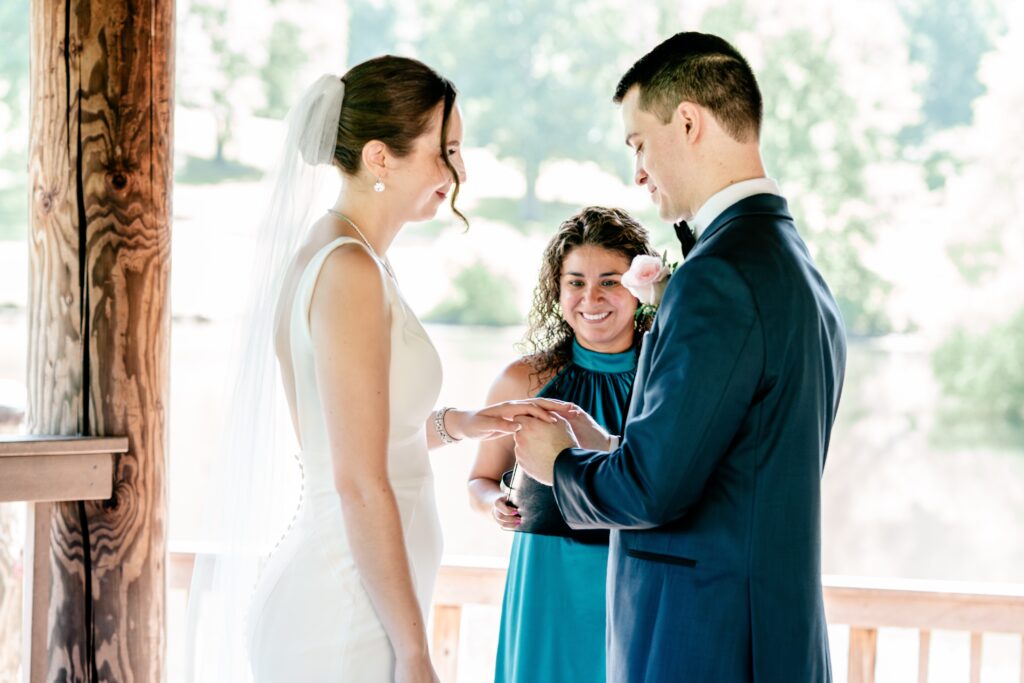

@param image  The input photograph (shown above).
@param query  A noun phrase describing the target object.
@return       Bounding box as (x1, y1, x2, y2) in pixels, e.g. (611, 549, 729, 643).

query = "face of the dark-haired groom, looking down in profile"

(623, 86, 692, 223)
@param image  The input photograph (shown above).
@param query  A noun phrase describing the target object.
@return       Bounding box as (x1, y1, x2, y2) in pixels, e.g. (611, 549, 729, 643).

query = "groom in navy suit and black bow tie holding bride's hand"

(516, 33, 846, 683)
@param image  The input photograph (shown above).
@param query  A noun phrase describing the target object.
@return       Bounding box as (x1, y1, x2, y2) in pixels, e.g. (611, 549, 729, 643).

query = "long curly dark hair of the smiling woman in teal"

(519, 206, 657, 377)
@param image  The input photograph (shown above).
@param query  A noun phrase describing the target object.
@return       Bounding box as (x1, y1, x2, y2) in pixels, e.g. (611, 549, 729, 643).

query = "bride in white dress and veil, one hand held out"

(189, 56, 551, 683)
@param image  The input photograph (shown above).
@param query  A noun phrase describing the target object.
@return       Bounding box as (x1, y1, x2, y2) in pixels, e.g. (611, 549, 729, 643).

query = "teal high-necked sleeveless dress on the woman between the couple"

(495, 341, 637, 683)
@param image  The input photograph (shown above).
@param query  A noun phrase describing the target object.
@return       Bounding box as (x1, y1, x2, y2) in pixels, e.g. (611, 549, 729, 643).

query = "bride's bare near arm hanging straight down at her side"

(310, 248, 430, 680)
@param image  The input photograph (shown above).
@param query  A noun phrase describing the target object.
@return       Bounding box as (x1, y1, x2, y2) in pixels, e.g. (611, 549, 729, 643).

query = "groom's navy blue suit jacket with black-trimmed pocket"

(554, 195, 846, 683)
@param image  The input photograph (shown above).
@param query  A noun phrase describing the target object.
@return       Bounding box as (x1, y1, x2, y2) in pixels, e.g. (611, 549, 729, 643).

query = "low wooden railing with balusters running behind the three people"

(170, 552, 1024, 683)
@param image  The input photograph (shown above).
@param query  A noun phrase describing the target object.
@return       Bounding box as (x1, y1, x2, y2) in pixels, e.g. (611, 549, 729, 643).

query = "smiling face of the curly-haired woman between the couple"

(558, 245, 637, 353)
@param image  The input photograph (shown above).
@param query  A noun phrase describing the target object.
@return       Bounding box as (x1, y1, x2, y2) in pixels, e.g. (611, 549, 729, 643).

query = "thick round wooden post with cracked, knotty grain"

(24, 0, 174, 681)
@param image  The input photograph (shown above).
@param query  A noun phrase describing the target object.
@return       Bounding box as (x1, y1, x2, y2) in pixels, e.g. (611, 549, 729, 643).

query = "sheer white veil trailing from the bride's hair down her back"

(185, 75, 345, 683)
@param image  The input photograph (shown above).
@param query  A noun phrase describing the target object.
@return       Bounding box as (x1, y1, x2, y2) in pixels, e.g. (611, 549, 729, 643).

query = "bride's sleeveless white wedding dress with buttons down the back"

(248, 238, 441, 683)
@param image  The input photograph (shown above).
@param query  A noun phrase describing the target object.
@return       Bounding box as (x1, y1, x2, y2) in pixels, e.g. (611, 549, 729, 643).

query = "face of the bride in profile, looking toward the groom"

(384, 102, 466, 221)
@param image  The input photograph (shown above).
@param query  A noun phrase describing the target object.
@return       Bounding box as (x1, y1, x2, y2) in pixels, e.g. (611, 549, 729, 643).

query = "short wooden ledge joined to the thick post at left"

(0, 436, 128, 503)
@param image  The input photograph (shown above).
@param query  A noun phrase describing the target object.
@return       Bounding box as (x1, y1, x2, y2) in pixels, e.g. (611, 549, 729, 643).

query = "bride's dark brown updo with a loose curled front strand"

(334, 54, 467, 222)
